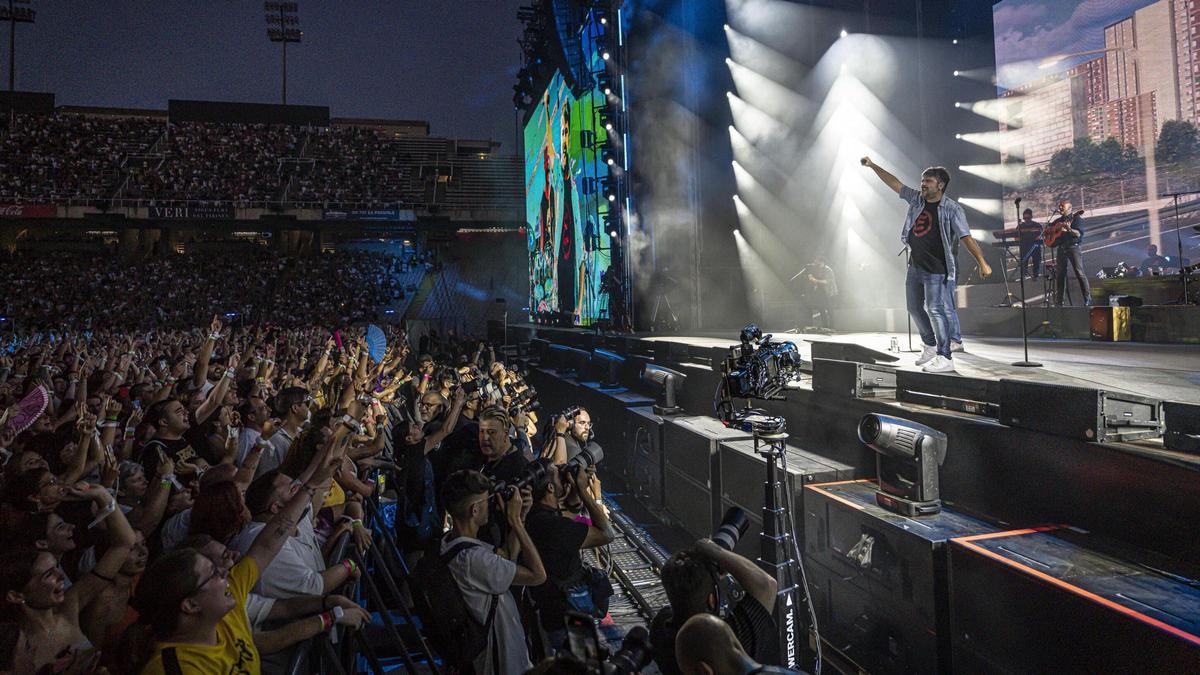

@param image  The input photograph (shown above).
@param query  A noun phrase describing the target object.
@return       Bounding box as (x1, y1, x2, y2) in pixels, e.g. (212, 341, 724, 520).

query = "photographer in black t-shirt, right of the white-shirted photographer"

(526, 459, 613, 656)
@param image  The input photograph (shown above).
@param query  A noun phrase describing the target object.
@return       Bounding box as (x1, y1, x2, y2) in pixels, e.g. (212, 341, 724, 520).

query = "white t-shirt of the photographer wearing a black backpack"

(442, 537, 533, 675)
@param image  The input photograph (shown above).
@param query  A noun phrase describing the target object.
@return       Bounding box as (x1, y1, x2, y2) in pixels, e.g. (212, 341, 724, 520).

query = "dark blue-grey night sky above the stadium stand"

(9, 0, 522, 153)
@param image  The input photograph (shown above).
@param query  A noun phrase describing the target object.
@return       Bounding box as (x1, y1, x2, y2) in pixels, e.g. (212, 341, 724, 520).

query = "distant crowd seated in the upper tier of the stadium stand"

(0, 112, 511, 209)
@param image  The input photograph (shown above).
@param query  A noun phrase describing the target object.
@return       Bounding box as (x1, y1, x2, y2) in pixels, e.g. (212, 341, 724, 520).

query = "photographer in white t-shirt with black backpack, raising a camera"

(440, 471, 546, 675)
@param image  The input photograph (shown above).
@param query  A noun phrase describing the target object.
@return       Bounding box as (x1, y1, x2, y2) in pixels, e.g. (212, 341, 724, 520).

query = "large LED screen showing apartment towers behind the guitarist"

(993, 0, 1200, 270)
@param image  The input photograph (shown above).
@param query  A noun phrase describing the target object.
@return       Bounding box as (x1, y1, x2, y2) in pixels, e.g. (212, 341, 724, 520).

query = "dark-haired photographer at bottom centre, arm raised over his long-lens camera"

(650, 539, 780, 675)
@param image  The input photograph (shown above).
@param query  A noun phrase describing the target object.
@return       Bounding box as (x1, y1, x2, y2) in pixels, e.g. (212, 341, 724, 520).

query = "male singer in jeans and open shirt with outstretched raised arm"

(862, 157, 991, 372)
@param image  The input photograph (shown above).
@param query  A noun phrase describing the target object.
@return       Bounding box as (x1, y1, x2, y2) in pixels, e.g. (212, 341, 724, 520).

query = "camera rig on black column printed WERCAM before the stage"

(713, 323, 821, 675)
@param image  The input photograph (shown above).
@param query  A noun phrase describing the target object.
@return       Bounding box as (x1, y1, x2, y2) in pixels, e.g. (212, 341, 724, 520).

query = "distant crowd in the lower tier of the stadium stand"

(0, 246, 417, 330)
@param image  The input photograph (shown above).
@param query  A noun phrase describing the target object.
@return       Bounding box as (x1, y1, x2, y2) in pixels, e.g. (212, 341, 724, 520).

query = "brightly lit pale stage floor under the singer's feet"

(640, 329, 1200, 402)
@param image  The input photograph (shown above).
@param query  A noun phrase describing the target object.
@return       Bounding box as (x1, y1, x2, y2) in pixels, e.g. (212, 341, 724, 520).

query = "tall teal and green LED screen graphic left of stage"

(524, 63, 617, 325)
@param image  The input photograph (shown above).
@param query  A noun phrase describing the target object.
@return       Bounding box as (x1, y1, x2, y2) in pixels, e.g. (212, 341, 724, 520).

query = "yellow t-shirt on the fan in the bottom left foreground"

(142, 557, 262, 675)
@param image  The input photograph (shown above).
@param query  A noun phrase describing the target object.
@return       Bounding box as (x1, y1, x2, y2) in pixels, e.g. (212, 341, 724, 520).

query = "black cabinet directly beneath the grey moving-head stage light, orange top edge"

(804, 480, 995, 675)
